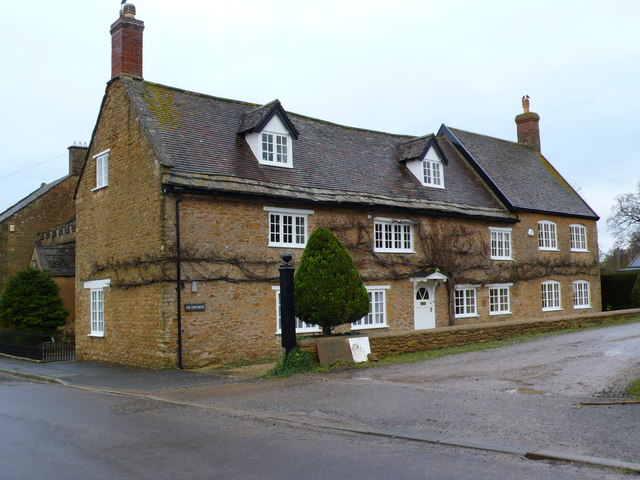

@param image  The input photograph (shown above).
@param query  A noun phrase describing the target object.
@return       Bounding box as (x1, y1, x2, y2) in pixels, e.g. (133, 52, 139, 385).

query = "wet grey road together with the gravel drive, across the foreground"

(0, 325, 640, 480)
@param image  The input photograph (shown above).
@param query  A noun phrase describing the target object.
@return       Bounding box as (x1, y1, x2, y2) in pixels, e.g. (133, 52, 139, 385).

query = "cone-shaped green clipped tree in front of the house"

(294, 228, 369, 335)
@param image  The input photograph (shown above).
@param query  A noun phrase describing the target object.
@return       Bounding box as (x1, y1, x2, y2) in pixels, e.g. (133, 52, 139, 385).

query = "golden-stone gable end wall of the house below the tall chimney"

(76, 79, 175, 368)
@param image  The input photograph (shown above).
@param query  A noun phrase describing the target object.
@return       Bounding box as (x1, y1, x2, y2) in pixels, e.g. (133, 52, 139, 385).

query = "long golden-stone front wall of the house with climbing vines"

(165, 195, 600, 366)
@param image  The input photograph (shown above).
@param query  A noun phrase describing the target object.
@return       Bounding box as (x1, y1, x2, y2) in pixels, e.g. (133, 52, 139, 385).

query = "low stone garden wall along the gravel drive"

(298, 309, 640, 356)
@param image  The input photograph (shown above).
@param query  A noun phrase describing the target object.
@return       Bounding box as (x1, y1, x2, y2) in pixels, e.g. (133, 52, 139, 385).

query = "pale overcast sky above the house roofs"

(0, 0, 640, 252)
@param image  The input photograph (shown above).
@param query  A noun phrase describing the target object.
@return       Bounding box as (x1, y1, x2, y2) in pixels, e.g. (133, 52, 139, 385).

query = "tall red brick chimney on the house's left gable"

(111, 1, 144, 78)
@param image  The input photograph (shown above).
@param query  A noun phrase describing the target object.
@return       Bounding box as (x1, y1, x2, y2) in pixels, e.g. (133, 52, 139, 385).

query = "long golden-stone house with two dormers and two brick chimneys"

(76, 4, 601, 368)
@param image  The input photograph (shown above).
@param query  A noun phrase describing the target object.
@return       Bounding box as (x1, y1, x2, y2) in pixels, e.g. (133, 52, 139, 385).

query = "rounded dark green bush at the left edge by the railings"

(0, 268, 68, 333)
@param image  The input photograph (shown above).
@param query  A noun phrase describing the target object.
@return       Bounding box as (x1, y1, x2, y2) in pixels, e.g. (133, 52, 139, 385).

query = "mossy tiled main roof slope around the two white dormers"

(122, 78, 507, 216)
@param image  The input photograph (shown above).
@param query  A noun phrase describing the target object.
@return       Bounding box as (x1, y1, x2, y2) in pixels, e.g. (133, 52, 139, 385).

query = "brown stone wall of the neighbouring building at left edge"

(0, 176, 78, 292)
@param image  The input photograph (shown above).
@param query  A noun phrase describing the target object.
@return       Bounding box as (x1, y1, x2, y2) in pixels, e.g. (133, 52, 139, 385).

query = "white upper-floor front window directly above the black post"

(264, 207, 313, 248)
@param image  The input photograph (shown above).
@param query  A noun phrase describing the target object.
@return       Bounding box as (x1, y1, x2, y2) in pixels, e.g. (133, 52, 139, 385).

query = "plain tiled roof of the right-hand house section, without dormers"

(441, 126, 598, 218)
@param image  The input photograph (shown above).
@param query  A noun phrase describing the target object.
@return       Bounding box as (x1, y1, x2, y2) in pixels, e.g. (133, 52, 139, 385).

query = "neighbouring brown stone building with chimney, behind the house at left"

(0, 145, 87, 292)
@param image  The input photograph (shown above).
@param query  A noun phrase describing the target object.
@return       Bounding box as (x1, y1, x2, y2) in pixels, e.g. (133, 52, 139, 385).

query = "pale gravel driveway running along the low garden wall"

(155, 324, 640, 462)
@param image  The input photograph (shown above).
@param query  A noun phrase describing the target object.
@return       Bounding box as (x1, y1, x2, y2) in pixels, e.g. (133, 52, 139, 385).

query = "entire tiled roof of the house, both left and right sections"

(119, 76, 595, 220)
